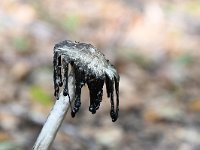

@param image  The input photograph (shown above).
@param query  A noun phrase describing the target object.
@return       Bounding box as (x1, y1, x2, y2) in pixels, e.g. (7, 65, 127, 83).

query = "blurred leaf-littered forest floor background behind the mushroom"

(0, 0, 200, 150)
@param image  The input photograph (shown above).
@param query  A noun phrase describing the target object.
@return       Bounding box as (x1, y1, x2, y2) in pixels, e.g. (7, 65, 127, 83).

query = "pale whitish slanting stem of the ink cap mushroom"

(33, 70, 74, 150)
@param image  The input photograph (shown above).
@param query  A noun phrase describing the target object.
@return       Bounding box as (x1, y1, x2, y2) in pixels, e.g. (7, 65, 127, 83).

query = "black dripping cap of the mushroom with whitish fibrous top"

(53, 40, 120, 122)
